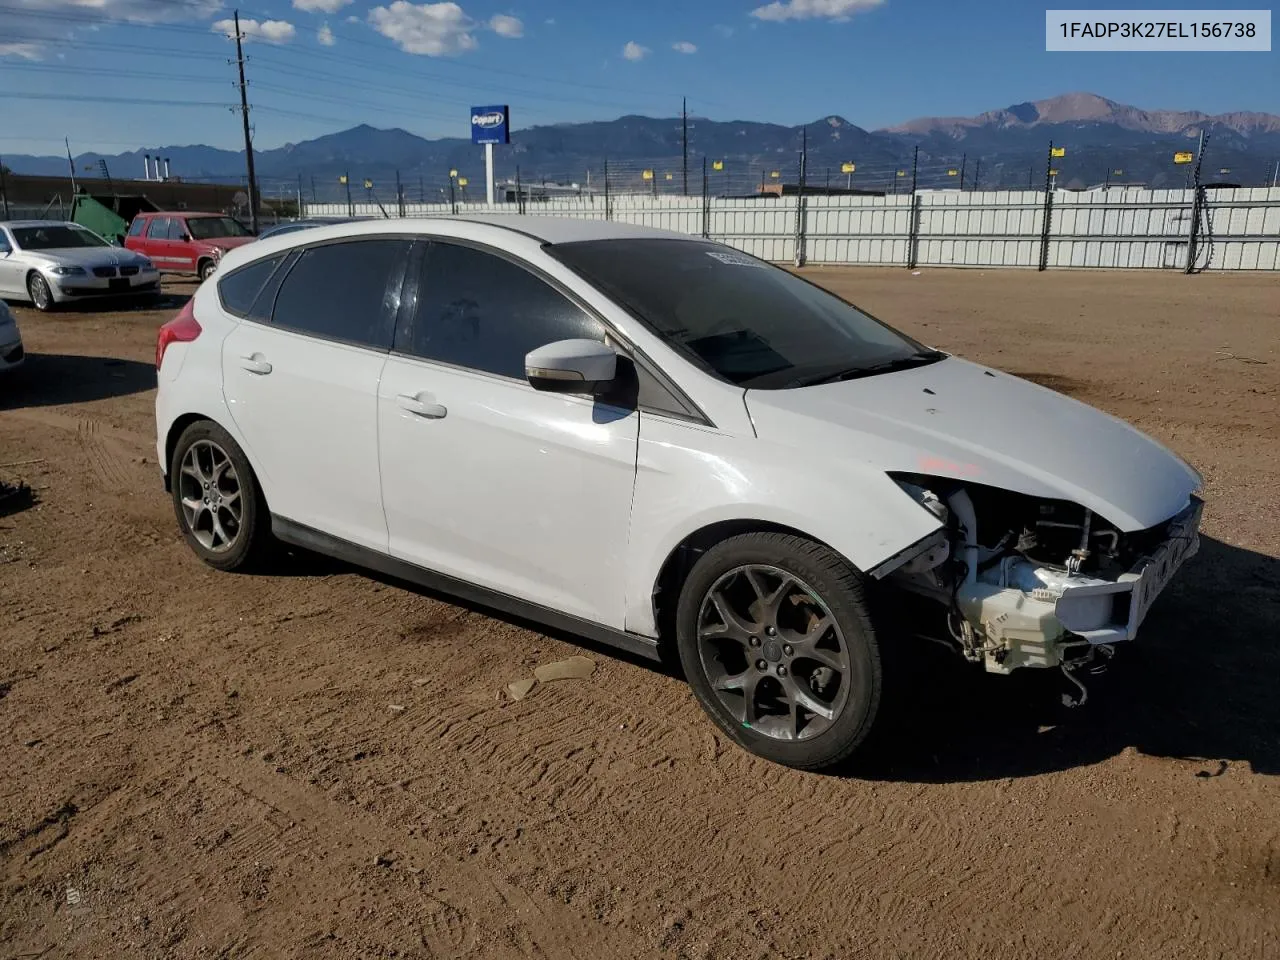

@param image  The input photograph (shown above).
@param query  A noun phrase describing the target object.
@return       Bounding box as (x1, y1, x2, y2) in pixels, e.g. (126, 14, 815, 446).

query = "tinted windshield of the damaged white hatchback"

(548, 239, 942, 389)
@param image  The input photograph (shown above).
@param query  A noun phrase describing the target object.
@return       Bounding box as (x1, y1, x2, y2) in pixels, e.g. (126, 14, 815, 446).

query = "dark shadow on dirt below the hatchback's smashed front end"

(850, 536, 1280, 783)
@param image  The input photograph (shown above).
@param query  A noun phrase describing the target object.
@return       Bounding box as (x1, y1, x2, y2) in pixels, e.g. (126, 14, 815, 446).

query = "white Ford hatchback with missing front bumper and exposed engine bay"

(156, 216, 1201, 768)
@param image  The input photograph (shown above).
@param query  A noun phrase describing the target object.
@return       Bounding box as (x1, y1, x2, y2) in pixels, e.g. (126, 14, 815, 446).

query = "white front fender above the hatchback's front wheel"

(626, 417, 941, 636)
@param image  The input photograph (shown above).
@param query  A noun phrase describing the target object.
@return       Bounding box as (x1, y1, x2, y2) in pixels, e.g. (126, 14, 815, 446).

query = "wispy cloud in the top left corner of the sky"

(0, 0, 223, 60)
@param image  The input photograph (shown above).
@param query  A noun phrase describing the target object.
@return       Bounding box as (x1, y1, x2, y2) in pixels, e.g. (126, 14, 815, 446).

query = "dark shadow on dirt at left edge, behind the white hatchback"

(0, 353, 156, 410)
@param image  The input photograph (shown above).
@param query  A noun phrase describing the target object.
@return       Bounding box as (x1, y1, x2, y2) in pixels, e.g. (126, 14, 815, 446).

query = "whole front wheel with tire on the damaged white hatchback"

(676, 532, 883, 769)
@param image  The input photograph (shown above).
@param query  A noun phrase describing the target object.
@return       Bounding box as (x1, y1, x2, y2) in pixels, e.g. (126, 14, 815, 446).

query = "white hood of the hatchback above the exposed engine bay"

(746, 357, 1201, 531)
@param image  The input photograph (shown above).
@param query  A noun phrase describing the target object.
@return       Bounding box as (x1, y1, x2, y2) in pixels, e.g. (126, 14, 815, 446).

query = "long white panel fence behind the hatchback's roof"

(306, 187, 1280, 270)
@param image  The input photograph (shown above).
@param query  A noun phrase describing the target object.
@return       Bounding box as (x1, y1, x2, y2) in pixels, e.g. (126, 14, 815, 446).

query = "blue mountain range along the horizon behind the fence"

(5, 93, 1280, 198)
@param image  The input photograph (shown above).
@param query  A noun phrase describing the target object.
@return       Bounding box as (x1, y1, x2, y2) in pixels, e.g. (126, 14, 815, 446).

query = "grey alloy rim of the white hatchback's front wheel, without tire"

(698, 563, 850, 740)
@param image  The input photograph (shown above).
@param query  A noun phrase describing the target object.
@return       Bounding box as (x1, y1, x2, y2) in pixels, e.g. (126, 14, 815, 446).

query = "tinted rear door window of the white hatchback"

(271, 239, 408, 349)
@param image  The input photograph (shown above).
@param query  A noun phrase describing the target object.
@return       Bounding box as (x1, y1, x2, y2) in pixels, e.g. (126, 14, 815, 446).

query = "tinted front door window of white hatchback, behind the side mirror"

(407, 243, 604, 380)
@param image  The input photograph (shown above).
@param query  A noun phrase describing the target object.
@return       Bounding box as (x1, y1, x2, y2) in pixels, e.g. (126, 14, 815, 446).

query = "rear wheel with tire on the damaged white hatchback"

(169, 420, 270, 571)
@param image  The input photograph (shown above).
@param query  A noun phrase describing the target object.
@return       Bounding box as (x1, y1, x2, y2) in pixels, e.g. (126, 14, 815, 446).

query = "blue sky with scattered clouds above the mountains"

(0, 0, 1280, 155)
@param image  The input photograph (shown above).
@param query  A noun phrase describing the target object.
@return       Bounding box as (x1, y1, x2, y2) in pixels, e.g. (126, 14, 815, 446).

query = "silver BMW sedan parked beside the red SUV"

(0, 220, 160, 310)
